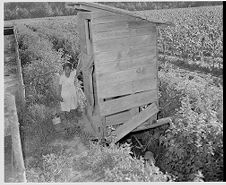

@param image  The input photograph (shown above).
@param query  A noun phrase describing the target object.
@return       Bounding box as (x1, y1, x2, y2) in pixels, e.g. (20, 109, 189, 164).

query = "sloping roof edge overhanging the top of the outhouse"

(66, 2, 173, 26)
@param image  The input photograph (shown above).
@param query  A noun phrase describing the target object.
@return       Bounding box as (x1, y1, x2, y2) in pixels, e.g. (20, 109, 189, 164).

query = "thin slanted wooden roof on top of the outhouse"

(66, 2, 173, 26)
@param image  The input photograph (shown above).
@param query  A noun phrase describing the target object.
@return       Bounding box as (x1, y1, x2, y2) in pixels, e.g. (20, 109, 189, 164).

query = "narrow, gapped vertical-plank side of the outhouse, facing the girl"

(80, 13, 105, 138)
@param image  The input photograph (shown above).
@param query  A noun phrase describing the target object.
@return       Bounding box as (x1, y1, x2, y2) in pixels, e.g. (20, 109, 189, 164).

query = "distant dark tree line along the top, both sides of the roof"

(4, 1, 222, 20)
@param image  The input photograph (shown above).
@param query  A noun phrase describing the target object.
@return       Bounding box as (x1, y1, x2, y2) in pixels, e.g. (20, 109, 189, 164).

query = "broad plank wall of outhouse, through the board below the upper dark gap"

(91, 11, 158, 116)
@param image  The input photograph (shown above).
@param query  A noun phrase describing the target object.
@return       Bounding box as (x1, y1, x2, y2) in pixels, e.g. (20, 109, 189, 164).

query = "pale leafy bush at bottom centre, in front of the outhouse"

(73, 144, 170, 182)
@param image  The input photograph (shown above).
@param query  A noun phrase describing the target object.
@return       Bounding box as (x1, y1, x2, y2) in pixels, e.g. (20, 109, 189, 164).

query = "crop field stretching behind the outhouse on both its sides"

(7, 6, 223, 76)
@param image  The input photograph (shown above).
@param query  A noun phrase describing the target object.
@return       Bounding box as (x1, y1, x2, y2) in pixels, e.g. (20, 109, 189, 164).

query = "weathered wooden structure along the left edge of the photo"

(4, 26, 26, 182)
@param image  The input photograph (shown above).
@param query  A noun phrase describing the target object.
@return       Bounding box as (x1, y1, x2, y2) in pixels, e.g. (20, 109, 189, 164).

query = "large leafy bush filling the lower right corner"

(161, 97, 223, 181)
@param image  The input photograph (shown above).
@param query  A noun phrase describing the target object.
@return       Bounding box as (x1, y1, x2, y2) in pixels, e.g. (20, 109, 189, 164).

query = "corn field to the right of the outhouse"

(140, 6, 223, 76)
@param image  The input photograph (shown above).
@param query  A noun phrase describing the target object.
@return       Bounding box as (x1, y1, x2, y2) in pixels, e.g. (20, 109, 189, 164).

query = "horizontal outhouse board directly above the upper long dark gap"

(98, 77, 157, 98)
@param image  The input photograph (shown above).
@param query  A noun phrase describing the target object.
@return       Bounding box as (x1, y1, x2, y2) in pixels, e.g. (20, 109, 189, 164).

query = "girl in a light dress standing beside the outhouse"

(59, 63, 78, 122)
